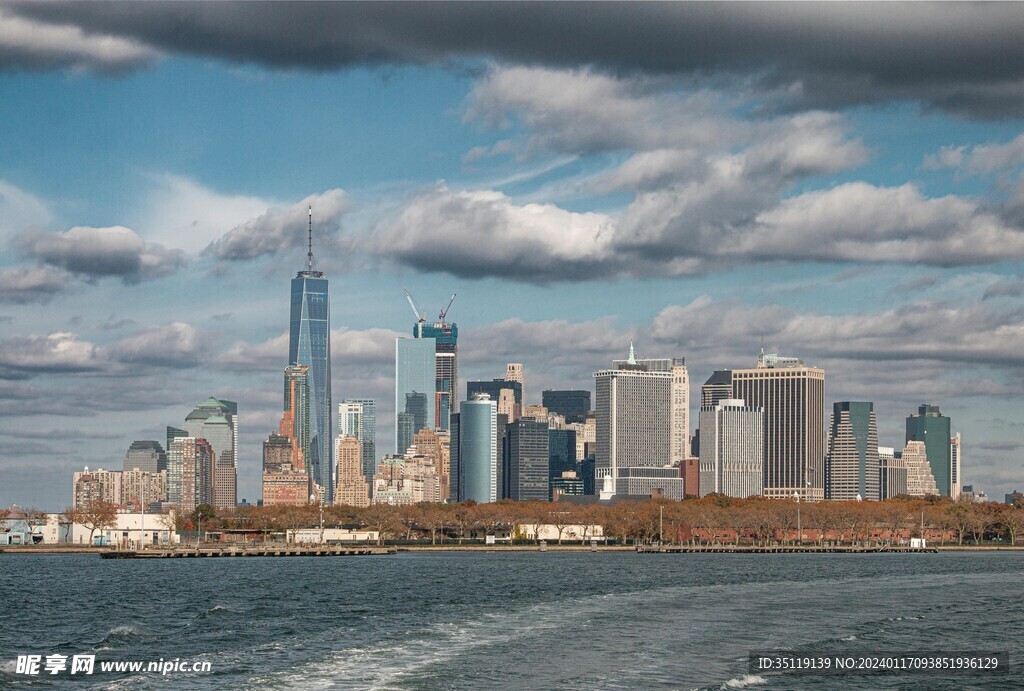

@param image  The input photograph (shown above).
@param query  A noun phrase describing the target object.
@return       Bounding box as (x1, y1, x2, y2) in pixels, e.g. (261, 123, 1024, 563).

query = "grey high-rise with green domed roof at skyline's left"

(182, 397, 239, 509)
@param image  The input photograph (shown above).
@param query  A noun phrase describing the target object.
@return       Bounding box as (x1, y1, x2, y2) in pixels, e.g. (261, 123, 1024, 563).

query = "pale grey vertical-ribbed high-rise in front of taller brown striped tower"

(700, 398, 765, 499)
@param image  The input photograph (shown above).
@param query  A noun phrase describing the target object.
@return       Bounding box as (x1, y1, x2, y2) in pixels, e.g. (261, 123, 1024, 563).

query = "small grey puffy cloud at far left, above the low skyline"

(19, 225, 185, 284)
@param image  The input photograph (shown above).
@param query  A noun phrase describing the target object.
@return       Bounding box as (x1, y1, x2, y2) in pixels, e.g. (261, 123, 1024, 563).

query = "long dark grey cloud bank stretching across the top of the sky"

(6, 1, 1024, 117)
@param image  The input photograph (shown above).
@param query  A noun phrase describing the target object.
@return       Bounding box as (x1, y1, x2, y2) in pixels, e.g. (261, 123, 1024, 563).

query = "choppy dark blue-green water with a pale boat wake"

(0, 552, 1024, 690)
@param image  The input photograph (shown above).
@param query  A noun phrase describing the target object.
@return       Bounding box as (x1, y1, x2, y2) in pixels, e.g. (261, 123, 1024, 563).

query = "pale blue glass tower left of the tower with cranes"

(394, 337, 437, 456)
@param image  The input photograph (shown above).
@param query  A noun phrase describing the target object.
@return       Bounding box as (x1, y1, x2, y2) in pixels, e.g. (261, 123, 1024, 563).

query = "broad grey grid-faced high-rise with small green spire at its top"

(594, 345, 679, 485)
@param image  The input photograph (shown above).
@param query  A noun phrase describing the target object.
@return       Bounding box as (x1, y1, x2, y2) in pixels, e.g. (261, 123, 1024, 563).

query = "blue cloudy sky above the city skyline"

(0, 1, 1024, 511)
